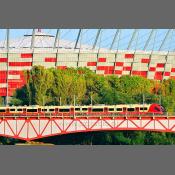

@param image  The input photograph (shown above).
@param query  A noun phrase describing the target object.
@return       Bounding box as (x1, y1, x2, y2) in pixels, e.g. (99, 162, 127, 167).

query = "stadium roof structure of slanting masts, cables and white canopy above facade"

(0, 29, 175, 52)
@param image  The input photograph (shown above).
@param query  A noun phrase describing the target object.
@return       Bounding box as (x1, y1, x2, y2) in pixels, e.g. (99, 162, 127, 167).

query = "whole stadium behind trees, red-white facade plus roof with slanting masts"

(0, 29, 175, 103)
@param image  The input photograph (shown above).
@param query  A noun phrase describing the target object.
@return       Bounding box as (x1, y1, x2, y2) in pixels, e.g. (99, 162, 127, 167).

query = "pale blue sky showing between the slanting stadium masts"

(0, 29, 175, 51)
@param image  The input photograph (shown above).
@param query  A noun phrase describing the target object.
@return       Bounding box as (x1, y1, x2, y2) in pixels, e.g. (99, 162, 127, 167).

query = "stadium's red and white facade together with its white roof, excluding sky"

(0, 31, 175, 102)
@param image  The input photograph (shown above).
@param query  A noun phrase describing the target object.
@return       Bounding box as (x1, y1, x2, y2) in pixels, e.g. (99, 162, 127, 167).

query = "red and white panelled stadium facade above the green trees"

(0, 49, 175, 96)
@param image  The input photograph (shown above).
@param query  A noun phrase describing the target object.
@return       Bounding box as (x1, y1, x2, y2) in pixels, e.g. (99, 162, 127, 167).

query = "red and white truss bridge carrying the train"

(0, 113, 175, 141)
